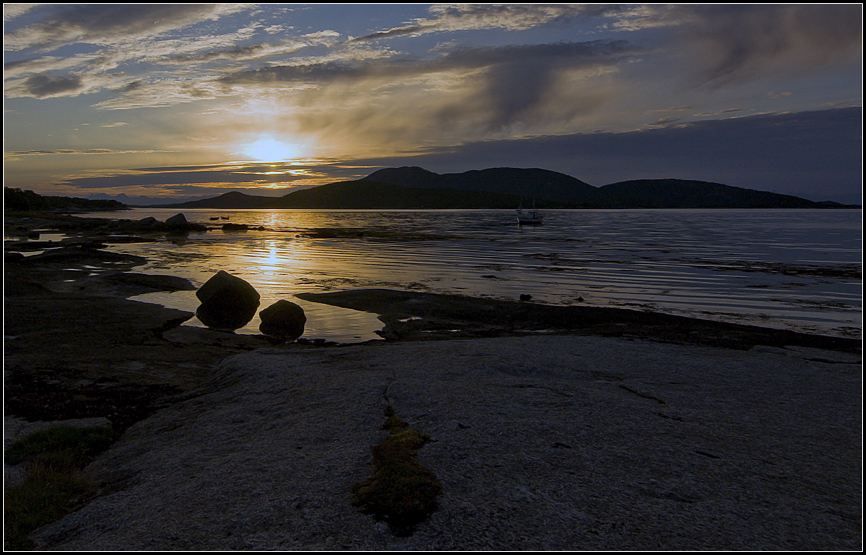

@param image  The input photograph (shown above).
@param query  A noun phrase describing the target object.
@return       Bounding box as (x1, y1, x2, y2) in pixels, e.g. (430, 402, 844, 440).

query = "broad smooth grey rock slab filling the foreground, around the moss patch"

(27, 336, 862, 550)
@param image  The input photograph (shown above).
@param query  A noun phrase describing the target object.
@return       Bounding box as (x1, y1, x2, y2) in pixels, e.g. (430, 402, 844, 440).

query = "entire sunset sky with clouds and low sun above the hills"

(3, 4, 863, 204)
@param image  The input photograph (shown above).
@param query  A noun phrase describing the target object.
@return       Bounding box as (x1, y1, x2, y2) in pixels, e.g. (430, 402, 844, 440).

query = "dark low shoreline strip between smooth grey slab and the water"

(4, 214, 862, 426)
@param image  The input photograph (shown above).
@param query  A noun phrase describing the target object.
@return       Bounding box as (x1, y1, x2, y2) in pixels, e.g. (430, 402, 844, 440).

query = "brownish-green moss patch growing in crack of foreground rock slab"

(352, 407, 442, 536)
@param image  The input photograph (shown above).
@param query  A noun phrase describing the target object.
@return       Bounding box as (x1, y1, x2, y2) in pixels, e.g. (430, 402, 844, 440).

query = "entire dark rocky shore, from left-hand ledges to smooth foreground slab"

(4, 212, 862, 550)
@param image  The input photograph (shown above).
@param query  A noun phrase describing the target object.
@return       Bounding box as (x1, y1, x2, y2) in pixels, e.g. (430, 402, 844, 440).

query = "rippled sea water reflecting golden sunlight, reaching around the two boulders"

(82, 208, 862, 342)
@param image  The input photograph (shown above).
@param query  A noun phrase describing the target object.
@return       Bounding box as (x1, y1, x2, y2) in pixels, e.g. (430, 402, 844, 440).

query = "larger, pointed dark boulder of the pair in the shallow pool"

(195, 270, 260, 331)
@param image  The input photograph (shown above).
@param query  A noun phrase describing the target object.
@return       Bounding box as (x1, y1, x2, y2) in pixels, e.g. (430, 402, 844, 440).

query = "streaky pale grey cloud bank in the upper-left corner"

(4, 4, 258, 105)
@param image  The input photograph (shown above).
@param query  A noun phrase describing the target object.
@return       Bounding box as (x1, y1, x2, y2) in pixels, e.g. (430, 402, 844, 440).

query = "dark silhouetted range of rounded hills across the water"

(150, 166, 843, 210)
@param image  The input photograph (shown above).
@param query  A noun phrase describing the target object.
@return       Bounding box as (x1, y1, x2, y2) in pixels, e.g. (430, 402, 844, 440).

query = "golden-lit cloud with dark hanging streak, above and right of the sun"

(219, 40, 640, 143)
